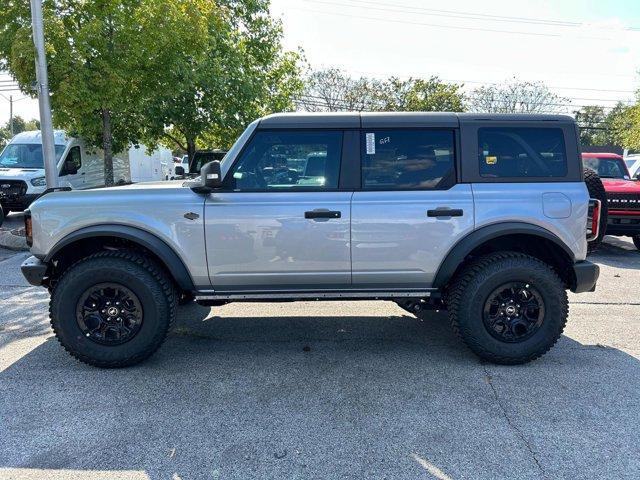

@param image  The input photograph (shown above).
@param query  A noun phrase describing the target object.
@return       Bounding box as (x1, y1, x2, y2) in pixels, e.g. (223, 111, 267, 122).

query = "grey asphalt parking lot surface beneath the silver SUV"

(0, 238, 640, 479)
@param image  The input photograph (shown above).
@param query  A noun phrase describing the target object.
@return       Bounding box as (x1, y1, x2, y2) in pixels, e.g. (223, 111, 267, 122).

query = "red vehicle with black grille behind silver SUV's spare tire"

(582, 153, 640, 250)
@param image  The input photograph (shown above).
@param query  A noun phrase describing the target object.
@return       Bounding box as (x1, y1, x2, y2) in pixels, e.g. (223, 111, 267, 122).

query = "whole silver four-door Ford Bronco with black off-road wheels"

(22, 113, 599, 367)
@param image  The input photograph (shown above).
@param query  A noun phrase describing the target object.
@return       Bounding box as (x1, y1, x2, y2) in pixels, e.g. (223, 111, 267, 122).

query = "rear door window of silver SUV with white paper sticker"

(362, 129, 455, 190)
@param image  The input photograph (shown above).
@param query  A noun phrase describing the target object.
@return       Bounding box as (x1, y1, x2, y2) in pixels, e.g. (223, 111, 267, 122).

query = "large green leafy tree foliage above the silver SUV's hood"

(0, 0, 301, 183)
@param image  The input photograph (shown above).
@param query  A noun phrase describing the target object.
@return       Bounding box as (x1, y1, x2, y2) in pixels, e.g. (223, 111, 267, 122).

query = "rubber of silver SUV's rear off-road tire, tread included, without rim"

(447, 252, 569, 365)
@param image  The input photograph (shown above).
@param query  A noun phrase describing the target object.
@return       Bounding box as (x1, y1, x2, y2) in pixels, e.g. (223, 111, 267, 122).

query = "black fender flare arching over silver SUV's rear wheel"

(433, 222, 575, 288)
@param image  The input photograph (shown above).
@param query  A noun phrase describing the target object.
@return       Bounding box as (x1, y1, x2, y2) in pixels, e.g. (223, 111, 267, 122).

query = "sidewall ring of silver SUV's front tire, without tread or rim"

(51, 258, 170, 362)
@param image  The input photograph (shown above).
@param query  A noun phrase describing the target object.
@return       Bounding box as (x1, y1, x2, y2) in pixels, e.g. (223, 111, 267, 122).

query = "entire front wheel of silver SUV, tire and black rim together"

(49, 251, 177, 368)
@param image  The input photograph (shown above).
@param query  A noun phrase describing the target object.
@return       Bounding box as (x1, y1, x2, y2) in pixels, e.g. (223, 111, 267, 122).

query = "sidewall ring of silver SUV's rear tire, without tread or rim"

(458, 262, 567, 358)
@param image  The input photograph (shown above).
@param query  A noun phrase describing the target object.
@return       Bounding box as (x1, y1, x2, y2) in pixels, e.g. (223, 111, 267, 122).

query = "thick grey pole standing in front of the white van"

(31, 0, 58, 188)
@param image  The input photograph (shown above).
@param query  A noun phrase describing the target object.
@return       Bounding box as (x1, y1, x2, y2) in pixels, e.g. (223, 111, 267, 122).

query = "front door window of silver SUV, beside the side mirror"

(231, 131, 342, 191)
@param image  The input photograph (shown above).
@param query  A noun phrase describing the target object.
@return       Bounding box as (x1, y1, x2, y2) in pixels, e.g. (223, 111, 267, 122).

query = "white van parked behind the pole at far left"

(0, 130, 131, 213)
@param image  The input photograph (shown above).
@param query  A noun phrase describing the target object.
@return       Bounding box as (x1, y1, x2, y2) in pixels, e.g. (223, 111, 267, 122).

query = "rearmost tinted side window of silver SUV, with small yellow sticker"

(478, 127, 567, 178)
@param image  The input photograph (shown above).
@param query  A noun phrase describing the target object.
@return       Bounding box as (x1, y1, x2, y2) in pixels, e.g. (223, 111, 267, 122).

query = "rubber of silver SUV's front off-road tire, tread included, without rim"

(49, 250, 177, 368)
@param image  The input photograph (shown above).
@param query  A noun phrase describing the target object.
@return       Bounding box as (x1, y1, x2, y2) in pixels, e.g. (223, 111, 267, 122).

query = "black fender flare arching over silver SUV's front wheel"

(42, 225, 195, 291)
